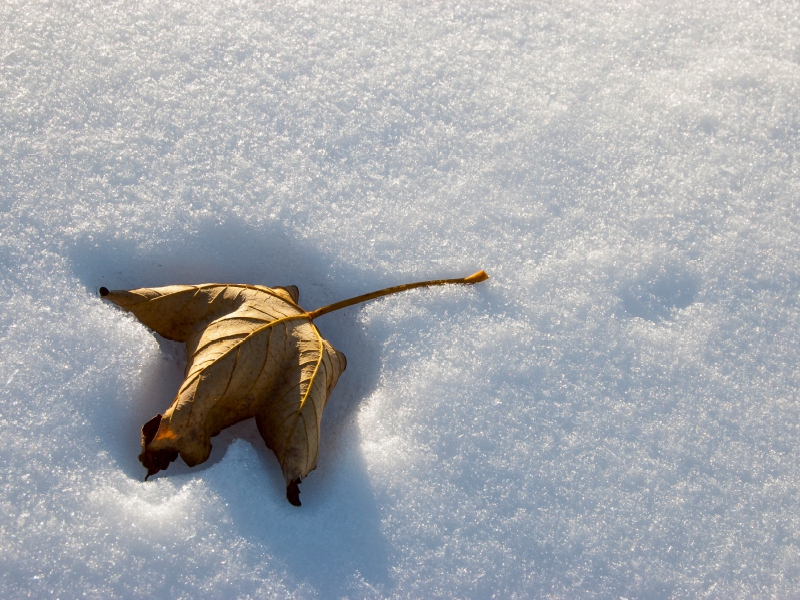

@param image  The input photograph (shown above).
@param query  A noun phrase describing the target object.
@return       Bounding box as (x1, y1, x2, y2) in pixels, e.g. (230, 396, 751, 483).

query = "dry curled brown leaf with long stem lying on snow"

(100, 271, 488, 506)
